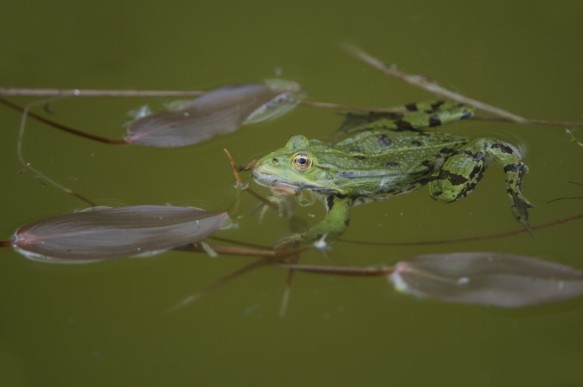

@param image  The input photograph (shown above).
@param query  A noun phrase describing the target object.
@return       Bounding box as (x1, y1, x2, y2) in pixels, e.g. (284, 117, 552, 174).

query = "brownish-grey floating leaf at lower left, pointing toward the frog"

(12, 205, 228, 262)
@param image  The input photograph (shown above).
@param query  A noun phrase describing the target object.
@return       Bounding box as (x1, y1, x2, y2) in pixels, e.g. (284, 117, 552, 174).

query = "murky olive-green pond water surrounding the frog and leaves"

(0, 1, 583, 386)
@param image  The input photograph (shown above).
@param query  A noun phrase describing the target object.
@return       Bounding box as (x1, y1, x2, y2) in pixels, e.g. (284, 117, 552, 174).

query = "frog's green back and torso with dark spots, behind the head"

(309, 129, 467, 200)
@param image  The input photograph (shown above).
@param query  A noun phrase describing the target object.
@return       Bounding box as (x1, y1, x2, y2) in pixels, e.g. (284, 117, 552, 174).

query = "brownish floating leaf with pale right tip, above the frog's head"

(125, 80, 300, 147)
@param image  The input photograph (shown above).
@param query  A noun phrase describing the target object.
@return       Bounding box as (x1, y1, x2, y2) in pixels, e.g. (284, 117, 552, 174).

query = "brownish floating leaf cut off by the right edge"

(389, 252, 583, 308)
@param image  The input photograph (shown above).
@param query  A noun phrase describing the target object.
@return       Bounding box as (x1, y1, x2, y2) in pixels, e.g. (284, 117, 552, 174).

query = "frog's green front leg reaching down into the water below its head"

(302, 195, 352, 241)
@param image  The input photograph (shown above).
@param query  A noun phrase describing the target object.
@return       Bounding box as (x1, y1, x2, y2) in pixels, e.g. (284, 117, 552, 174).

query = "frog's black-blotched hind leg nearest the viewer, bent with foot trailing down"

(428, 138, 532, 230)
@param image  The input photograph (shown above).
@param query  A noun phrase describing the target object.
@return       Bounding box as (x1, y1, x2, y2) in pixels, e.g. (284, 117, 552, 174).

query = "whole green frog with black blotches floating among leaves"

(253, 102, 531, 240)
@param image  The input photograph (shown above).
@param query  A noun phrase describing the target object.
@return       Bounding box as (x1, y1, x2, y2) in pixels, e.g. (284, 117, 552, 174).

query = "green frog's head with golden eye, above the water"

(253, 135, 333, 193)
